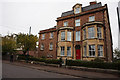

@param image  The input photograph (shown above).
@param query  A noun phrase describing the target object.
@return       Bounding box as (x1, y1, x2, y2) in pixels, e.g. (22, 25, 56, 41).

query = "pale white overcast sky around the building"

(0, 0, 119, 49)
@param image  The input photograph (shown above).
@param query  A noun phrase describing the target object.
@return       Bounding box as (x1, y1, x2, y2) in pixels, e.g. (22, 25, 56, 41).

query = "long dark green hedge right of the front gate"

(66, 60, 120, 70)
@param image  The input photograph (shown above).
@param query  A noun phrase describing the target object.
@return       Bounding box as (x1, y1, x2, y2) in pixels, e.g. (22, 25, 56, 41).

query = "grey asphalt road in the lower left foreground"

(2, 63, 78, 78)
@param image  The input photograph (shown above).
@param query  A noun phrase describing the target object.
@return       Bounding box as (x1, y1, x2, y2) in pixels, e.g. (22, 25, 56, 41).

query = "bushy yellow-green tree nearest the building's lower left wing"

(17, 33, 38, 54)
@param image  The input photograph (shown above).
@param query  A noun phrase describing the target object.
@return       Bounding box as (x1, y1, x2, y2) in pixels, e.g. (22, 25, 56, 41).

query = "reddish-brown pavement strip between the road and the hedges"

(3, 61, 120, 79)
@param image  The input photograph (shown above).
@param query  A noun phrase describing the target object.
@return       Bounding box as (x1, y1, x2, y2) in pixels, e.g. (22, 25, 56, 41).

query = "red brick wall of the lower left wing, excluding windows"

(38, 31, 57, 59)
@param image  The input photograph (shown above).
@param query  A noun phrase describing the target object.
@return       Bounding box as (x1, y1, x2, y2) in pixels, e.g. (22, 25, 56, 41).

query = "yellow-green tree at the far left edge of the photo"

(2, 35, 17, 55)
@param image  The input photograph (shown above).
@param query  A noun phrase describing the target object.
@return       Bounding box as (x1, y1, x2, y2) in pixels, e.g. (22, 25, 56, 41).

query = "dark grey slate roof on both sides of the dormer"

(61, 2, 102, 17)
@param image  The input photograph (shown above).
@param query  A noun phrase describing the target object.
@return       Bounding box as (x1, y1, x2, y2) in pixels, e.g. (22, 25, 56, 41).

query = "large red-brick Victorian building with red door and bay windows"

(38, 2, 113, 61)
